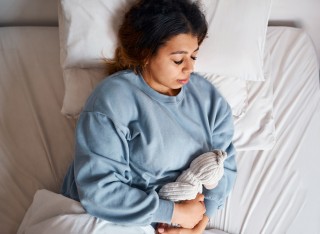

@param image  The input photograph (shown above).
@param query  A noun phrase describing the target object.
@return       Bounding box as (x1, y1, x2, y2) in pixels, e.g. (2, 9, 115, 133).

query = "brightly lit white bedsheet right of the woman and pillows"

(211, 28, 320, 234)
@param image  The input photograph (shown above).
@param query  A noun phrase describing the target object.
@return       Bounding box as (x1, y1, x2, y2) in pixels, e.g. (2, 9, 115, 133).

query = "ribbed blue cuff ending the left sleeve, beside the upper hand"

(152, 199, 174, 223)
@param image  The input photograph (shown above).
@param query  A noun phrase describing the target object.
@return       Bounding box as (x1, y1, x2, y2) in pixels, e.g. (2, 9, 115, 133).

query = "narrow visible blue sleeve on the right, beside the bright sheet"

(203, 99, 237, 217)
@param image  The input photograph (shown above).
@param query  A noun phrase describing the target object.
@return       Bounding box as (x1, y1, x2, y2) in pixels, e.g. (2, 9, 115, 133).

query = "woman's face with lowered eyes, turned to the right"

(142, 34, 199, 96)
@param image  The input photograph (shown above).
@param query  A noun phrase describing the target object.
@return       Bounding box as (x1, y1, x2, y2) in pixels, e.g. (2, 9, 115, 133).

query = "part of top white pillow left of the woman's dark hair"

(58, 0, 134, 68)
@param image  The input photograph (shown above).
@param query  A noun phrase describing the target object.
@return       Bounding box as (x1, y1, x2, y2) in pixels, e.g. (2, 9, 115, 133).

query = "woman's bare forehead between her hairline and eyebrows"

(159, 34, 199, 54)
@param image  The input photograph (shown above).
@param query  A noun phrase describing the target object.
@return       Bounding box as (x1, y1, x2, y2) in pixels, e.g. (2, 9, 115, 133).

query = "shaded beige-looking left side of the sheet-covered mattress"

(0, 27, 74, 234)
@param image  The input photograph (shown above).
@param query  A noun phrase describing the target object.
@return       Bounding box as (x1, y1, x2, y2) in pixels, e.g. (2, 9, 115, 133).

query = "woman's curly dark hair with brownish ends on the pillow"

(106, 0, 208, 74)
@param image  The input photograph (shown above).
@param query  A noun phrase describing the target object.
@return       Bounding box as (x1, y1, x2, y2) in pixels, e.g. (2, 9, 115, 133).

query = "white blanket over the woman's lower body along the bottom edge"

(18, 189, 229, 234)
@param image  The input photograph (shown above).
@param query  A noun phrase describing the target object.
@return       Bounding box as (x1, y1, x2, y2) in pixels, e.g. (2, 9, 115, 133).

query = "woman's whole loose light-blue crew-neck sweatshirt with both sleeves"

(62, 70, 236, 226)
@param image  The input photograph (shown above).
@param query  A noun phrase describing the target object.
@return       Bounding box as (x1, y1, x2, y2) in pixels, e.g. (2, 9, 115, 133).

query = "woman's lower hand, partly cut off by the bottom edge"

(156, 216, 209, 234)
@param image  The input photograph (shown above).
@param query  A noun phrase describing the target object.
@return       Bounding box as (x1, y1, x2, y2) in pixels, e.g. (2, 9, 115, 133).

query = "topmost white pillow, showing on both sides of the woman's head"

(59, 0, 271, 76)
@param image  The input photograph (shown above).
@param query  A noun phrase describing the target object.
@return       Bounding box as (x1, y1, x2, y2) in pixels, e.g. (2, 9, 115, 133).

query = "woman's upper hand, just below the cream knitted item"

(171, 193, 206, 229)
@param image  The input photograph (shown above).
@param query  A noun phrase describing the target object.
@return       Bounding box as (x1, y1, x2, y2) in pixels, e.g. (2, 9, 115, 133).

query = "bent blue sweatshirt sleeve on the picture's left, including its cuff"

(74, 112, 174, 225)
